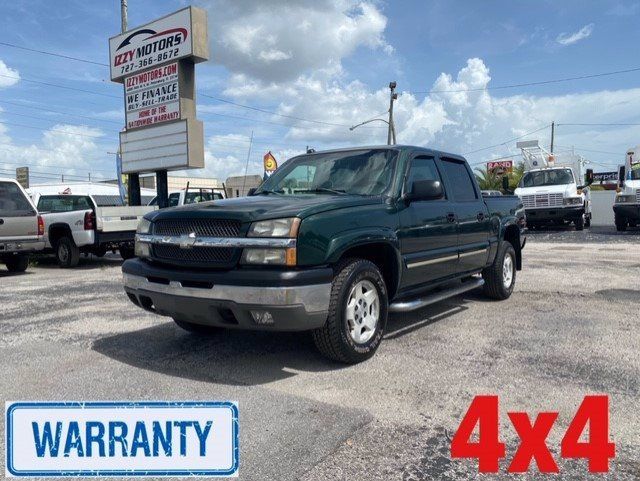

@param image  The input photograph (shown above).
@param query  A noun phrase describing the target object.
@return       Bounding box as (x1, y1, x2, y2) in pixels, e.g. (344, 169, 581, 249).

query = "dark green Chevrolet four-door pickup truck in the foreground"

(122, 145, 525, 363)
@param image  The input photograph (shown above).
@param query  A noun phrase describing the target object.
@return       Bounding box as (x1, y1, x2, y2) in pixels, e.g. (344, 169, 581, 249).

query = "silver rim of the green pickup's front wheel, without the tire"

(345, 280, 380, 344)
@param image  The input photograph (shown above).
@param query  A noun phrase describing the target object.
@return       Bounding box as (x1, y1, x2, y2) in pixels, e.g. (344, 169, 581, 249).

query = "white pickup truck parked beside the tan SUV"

(30, 186, 155, 267)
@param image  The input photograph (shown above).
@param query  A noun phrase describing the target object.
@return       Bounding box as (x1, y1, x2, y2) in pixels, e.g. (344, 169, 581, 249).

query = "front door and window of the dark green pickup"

(398, 155, 458, 288)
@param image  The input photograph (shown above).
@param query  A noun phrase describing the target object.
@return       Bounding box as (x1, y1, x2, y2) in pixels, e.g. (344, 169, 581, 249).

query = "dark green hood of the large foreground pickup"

(146, 194, 384, 222)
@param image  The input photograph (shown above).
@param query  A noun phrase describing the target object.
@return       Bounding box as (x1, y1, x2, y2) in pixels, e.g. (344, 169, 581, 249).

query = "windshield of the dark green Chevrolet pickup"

(256, 149, 398, 195)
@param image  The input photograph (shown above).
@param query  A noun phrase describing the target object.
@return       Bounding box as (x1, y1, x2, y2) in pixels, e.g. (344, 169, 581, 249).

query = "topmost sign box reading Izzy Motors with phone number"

(109, 7, 209, 82)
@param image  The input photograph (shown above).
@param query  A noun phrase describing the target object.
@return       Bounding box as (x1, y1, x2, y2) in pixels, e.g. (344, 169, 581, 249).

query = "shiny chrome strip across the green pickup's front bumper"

(123, 274, 331, 313)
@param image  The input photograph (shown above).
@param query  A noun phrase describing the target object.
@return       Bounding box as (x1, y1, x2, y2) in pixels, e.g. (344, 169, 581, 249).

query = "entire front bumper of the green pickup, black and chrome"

(122, 259, 333, 331)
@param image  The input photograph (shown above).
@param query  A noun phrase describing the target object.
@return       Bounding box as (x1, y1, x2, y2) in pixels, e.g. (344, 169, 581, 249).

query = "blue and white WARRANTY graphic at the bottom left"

(6, 401, 239, 477)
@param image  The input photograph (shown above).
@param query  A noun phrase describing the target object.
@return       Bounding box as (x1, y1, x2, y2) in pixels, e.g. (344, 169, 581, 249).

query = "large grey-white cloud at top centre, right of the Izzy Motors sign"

(205, 0, 393, 84)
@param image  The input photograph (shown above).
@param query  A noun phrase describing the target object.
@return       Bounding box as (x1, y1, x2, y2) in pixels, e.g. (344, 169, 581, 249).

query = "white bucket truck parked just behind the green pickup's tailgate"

(515, 140, 593, 230)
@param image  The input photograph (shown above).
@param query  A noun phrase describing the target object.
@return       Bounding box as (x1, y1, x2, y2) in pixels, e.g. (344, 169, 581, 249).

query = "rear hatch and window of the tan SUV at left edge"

(0, 181, 38, 244)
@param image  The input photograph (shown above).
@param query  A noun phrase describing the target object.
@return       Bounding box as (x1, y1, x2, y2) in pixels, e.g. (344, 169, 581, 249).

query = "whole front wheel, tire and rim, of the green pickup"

(313, 259, 389, 364)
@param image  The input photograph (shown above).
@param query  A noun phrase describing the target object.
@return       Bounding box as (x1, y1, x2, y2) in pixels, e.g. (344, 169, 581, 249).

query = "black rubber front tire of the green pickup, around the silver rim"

(313, 259, 389, 364)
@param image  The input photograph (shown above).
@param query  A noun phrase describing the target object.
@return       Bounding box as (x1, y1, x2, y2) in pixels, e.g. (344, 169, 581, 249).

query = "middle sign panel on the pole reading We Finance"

(124, 62, 180, 130)
